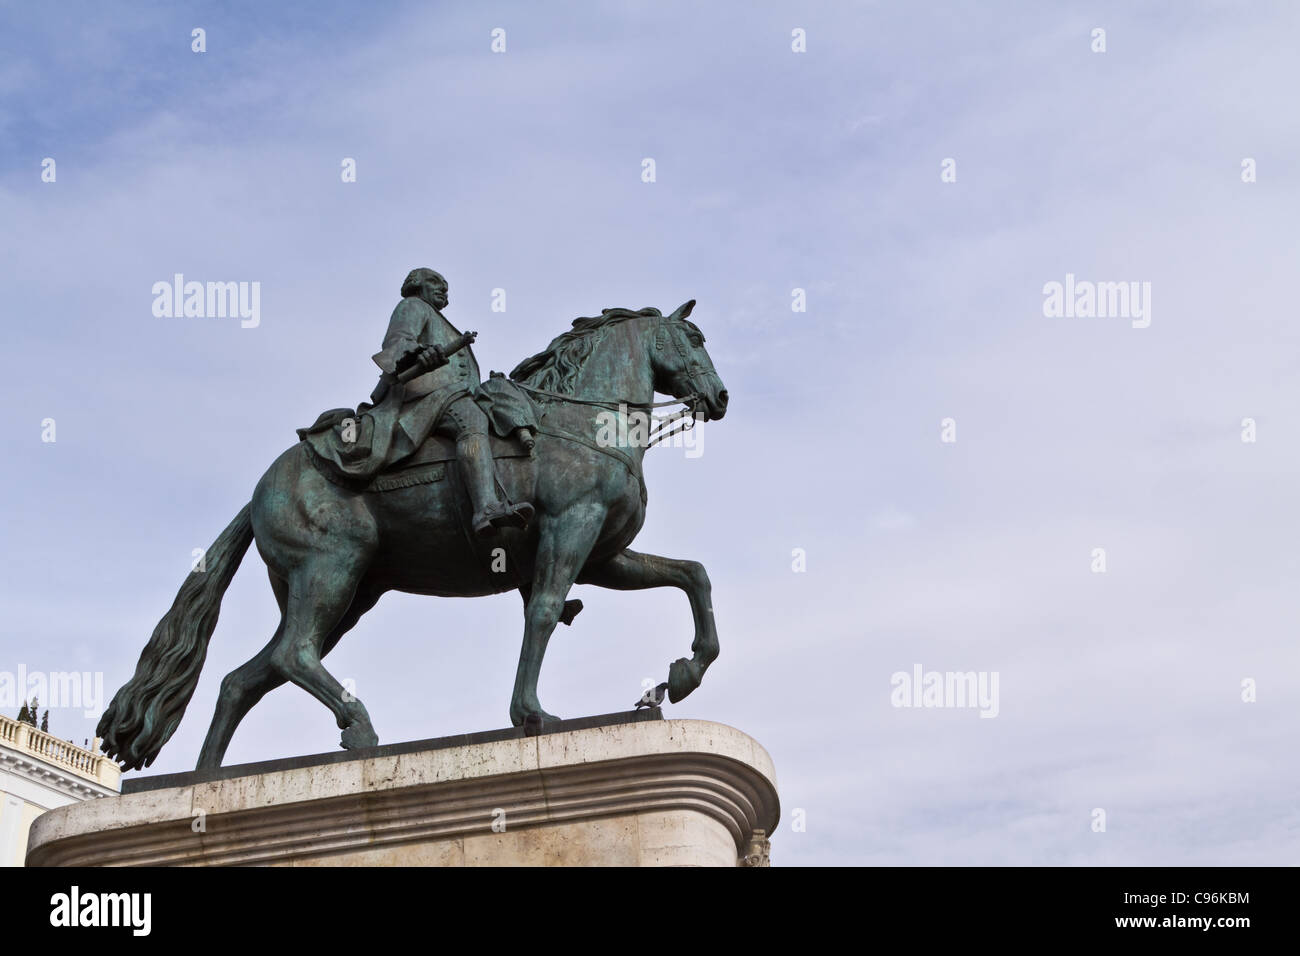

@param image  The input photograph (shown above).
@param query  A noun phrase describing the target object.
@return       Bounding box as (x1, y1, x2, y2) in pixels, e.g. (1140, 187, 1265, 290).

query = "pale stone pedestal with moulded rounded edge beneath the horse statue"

(27, 710, 780, 866)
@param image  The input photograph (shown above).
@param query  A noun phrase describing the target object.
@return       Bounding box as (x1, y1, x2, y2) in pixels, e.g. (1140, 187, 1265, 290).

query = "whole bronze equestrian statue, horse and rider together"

(98, 269, 728, 769)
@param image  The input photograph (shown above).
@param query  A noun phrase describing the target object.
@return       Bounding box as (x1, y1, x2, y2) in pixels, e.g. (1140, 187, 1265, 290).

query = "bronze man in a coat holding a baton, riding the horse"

(371, 269, 533, 537)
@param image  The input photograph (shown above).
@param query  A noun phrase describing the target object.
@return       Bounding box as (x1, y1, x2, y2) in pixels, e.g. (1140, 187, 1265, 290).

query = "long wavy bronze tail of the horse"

(95, 505, 252, 770)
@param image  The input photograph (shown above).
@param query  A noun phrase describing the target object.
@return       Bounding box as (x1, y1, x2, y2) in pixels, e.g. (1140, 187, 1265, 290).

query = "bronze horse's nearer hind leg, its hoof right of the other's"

(270, 561, 380, 750)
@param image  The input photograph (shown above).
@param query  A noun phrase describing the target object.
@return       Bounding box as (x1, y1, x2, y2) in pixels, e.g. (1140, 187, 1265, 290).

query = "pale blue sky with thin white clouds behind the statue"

(0, 0, 1300, 865)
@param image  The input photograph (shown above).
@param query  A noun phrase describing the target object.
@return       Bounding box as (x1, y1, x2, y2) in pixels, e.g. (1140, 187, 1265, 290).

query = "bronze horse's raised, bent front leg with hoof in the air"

(577, 550, 719, 704)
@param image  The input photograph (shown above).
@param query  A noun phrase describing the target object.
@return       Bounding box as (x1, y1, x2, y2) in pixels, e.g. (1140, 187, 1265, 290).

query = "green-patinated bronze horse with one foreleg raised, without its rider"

(96, 300, 727, 770)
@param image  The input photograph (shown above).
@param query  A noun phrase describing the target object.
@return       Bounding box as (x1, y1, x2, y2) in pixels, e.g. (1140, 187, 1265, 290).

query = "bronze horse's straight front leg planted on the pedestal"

(510, 503, 606, 727)
